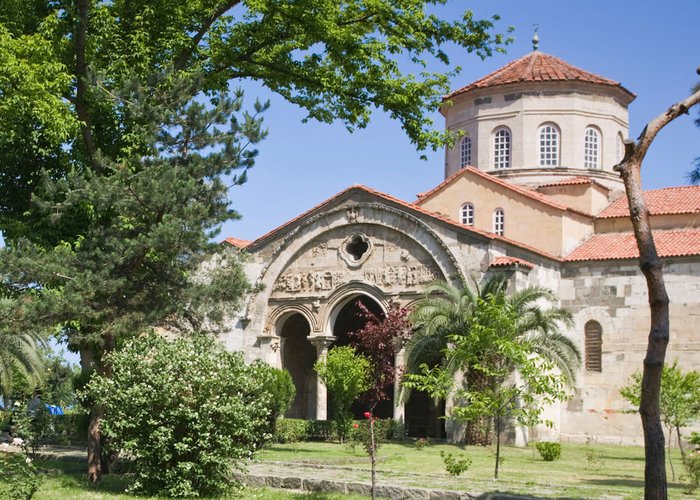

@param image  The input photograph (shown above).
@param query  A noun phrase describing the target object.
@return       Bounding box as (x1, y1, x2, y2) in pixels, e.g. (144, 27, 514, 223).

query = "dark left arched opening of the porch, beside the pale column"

(280, 313, 316, 419)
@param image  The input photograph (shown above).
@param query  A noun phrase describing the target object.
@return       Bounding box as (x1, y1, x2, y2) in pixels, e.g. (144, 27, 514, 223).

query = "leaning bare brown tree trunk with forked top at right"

(614, 68, 700, 499)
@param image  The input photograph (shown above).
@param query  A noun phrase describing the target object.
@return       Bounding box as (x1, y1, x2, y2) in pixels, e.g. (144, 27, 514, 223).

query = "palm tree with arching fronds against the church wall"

(404, 276, 581, 444)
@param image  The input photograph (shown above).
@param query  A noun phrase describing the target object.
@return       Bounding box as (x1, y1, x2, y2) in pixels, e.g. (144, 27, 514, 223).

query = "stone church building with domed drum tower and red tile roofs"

(224, 51, 700, 443)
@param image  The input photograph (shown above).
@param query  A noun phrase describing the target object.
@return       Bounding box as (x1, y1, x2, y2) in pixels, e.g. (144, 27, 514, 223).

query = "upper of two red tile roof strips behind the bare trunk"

(598, 186, 700, 219)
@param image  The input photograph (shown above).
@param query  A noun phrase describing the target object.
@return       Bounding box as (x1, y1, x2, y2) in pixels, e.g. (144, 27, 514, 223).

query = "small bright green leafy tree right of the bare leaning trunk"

(620, 360, 700, 476)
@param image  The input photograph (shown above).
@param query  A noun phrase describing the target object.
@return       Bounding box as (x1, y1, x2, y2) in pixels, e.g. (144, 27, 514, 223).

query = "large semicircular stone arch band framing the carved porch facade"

(244, 202, 465, 334)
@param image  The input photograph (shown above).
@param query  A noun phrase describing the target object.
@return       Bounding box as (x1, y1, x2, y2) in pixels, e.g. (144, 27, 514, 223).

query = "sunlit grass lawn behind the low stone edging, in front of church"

(257, 443, 697, 499)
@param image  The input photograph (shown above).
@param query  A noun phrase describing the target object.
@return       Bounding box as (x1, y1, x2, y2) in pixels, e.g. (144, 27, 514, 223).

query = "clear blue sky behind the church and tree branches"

(219, 0, 700, 240)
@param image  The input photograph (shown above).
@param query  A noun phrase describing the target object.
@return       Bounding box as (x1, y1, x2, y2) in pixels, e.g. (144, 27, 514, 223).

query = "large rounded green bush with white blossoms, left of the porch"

(87, 334, 272, 496)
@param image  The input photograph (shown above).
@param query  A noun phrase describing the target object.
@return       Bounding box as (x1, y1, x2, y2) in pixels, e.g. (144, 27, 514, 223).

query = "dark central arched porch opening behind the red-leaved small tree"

(328, 295, 394, 419)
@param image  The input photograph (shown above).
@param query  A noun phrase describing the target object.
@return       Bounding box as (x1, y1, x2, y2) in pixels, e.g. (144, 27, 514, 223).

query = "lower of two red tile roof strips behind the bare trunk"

(565, 229, 700, 262)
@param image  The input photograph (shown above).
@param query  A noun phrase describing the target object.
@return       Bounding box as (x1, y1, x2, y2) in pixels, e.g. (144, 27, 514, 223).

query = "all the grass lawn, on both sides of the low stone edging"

(13, 443, 697, 500)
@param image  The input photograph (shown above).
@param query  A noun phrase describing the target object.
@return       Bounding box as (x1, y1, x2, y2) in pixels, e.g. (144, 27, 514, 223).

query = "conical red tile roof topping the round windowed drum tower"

(444, 51, 634, 99)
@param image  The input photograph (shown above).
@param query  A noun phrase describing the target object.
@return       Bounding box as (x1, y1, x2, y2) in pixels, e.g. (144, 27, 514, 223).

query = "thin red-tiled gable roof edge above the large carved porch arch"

(224, 183, 562, 262)
